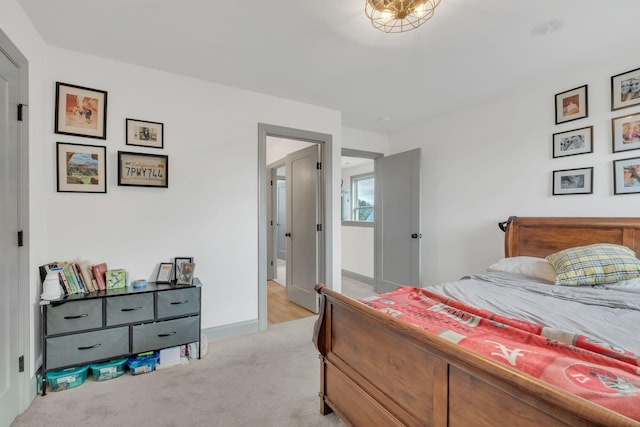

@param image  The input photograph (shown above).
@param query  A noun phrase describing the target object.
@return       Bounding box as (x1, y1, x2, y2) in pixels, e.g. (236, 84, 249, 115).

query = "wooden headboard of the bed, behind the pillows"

(500, 217, 640, 258)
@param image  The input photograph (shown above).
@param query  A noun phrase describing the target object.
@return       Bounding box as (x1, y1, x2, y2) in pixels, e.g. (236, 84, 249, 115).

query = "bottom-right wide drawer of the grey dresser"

(131, 316, 200, 353)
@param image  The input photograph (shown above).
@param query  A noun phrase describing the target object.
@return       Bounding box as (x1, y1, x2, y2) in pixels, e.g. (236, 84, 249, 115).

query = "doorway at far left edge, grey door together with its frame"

(0, 30, 30, 425)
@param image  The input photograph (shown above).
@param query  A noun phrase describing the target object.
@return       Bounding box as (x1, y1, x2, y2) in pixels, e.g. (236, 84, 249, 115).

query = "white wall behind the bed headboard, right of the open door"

(390, 52, 640, 284)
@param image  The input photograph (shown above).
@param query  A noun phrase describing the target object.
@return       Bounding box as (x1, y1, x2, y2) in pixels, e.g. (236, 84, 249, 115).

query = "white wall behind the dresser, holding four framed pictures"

(0, 0, 341, 374)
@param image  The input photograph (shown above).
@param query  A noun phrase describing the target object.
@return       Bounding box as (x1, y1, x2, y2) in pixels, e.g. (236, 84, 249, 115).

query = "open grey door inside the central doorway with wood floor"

(286, 144, 319, 313)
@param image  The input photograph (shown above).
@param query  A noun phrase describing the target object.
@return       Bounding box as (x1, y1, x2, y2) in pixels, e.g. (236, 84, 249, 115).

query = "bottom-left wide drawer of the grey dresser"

(46, 326, 129, 369)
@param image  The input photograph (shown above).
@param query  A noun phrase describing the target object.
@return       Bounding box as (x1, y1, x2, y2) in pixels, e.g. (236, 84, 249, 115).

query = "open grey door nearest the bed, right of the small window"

(375, 149, 422, 293)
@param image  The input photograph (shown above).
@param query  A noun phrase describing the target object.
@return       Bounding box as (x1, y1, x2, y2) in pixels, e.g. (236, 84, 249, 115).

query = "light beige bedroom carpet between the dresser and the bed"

(11, 316, 344, 427)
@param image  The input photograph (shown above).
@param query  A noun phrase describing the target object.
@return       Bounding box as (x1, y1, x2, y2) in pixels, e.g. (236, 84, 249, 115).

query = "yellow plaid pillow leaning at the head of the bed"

(547, 243, 640, 286)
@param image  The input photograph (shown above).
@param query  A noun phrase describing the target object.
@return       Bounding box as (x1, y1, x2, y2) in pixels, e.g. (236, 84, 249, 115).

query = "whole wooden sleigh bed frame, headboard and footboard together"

(314, 217, 640, 427)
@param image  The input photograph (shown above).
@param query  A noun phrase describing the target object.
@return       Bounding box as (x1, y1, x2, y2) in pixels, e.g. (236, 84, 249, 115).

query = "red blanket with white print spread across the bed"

(360, 286, 640, 421)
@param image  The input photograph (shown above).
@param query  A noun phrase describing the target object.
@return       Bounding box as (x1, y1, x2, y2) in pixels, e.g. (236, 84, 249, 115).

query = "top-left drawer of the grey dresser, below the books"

(46, 298, 102, 335)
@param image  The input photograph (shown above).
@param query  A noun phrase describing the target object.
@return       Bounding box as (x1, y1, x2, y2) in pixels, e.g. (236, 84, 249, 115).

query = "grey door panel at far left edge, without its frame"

(0, 41, 20, 425)
